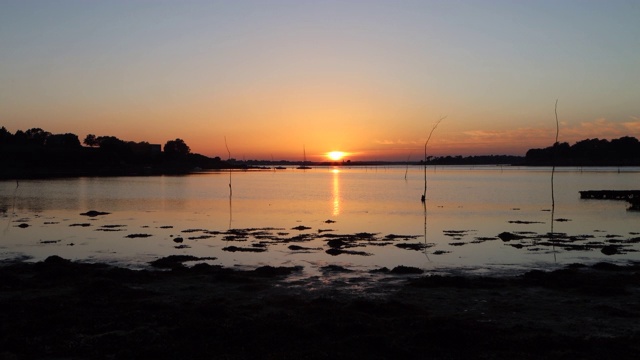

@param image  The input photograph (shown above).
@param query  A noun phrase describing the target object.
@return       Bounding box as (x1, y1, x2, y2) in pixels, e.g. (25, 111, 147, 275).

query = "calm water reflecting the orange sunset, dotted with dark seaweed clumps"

(0, 166, 640, 273)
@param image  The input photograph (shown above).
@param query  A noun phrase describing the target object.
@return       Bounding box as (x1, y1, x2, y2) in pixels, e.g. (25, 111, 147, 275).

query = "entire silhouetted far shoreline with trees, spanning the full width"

(0, 127, 640, 179)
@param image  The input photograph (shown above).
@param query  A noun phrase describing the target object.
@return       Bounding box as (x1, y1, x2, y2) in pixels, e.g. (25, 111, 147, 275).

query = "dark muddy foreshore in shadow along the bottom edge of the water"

(0, 257, 640, 359)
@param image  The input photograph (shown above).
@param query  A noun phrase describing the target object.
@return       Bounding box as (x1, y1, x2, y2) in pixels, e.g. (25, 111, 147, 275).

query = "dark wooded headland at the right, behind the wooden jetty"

(525, 136, 640, 166)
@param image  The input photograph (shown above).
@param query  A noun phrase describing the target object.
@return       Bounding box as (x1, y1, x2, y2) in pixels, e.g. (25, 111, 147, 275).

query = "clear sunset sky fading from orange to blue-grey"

(0, 0, 640, 161)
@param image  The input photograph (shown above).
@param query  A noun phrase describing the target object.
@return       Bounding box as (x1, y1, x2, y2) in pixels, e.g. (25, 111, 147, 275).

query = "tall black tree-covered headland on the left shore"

(0, 127, 227, 178)
